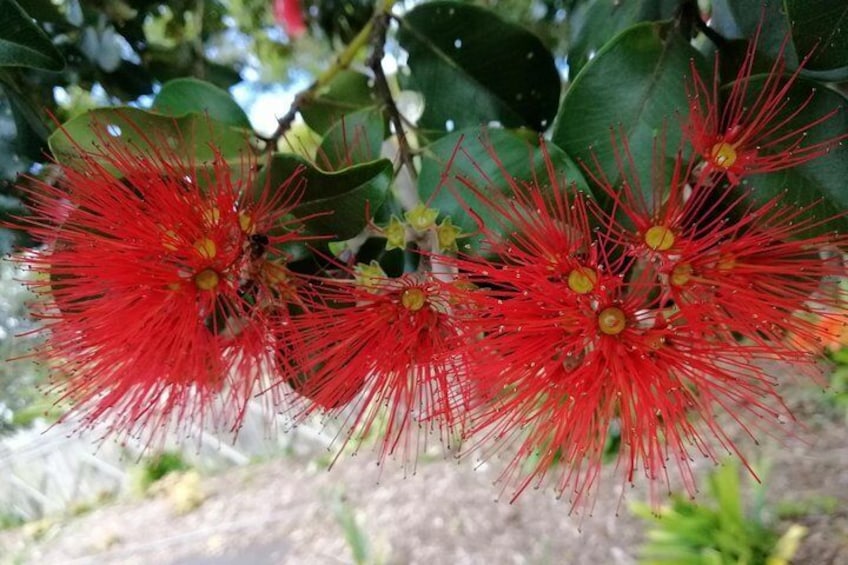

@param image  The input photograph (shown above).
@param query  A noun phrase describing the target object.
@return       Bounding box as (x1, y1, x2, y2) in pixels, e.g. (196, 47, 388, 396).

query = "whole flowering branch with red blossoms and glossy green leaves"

(0, 0, 848, 506)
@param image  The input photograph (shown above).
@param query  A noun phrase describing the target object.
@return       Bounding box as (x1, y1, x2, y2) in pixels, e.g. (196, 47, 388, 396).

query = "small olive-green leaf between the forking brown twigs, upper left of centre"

(300, 70, 374, 135)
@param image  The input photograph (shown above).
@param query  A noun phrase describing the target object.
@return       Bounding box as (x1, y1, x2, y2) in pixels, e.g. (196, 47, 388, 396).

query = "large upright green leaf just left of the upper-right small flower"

(552, 23, 705, 184)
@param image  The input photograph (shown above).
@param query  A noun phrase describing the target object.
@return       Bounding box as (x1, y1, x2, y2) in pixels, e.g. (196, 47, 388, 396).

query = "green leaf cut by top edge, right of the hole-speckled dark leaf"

(568, 0, 679, 76)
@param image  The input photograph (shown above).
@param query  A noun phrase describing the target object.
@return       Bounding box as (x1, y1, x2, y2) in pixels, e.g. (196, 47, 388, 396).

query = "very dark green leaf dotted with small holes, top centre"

(398, 2, 560, 138)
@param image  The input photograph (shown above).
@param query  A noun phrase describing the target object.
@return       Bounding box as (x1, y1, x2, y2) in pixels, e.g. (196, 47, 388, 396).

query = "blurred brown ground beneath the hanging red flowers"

(0, 382, 848, 565)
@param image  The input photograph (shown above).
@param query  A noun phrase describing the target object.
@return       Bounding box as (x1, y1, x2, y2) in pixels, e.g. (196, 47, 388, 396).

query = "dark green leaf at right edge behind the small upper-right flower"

(744, 76, 848, 233)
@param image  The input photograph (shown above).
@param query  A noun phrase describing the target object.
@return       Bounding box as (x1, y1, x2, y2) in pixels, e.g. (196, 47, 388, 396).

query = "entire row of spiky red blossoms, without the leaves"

(13, 34, 848, 504)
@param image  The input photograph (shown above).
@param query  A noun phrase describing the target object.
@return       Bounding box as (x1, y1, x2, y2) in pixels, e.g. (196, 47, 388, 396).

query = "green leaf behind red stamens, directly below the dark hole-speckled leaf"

(418, 128, 588, 251)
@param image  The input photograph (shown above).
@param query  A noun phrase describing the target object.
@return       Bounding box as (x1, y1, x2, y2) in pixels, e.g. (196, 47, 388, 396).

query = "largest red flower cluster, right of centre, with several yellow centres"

(438, 135, 845, 505)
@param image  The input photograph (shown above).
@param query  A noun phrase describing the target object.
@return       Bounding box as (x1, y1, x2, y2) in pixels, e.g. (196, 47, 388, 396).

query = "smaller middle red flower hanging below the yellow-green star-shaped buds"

(294, 265, 476, 463)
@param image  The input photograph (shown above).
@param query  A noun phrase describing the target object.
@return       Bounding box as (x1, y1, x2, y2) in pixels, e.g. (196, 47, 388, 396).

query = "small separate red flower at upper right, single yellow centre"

(685, 25, 848, 184)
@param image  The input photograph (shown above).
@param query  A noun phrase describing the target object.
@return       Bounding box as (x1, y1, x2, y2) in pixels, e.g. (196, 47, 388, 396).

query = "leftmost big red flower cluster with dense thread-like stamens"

(14, 119, 314, 434)
